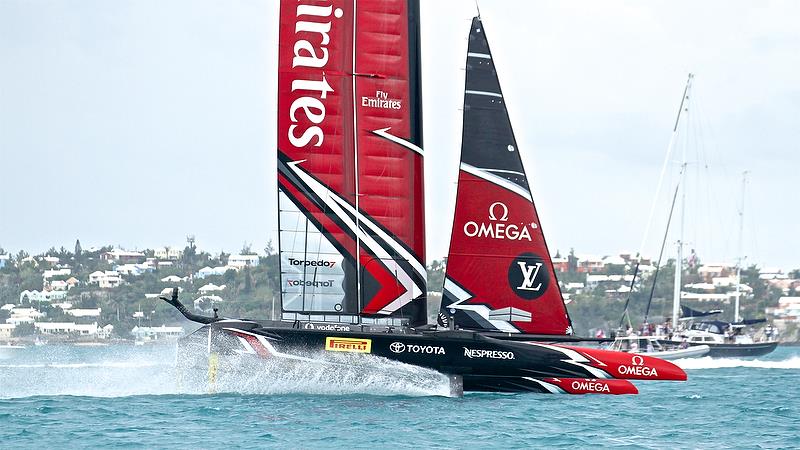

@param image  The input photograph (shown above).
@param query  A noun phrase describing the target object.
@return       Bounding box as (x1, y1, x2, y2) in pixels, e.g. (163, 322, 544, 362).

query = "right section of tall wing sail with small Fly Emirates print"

(354, 0, 425, 320)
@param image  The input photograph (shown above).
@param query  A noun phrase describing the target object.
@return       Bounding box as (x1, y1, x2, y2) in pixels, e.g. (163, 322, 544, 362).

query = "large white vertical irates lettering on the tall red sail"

(286, 2, 344, 147)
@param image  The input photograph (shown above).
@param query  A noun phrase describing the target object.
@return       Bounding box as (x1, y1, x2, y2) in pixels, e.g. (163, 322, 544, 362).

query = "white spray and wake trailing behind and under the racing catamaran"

(0, 346, 450, 398)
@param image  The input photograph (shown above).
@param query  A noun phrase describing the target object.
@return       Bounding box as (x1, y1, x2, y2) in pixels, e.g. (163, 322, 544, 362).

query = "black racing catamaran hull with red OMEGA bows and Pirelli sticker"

(177, 320, 686, 394)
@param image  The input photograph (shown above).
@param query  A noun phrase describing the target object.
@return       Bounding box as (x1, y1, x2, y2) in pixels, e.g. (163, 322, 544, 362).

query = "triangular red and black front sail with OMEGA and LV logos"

(439, 17, 572, 335)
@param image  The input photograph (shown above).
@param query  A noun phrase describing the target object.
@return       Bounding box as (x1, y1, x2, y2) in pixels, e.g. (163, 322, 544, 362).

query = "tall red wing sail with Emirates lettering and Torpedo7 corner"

(278, 0, 425, 324)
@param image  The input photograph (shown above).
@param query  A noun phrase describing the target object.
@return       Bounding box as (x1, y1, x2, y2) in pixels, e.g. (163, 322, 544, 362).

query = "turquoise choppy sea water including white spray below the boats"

(0, 345, 800, 449)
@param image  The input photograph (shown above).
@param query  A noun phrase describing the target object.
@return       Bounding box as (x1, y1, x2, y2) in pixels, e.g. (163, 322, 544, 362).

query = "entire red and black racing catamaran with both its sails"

(164, 0, 686, 394)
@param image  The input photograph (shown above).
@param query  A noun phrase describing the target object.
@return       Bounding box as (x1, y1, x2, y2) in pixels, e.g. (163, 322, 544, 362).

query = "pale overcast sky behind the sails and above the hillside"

(0, 0, 800, 269)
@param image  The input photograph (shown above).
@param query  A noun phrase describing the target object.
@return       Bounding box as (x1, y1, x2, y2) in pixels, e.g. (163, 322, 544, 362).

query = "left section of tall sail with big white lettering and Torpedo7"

(277, 0, 358, 314)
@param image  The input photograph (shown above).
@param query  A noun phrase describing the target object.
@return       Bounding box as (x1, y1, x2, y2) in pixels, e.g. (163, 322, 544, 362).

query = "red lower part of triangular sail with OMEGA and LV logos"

(442, 170, 570, 335)
